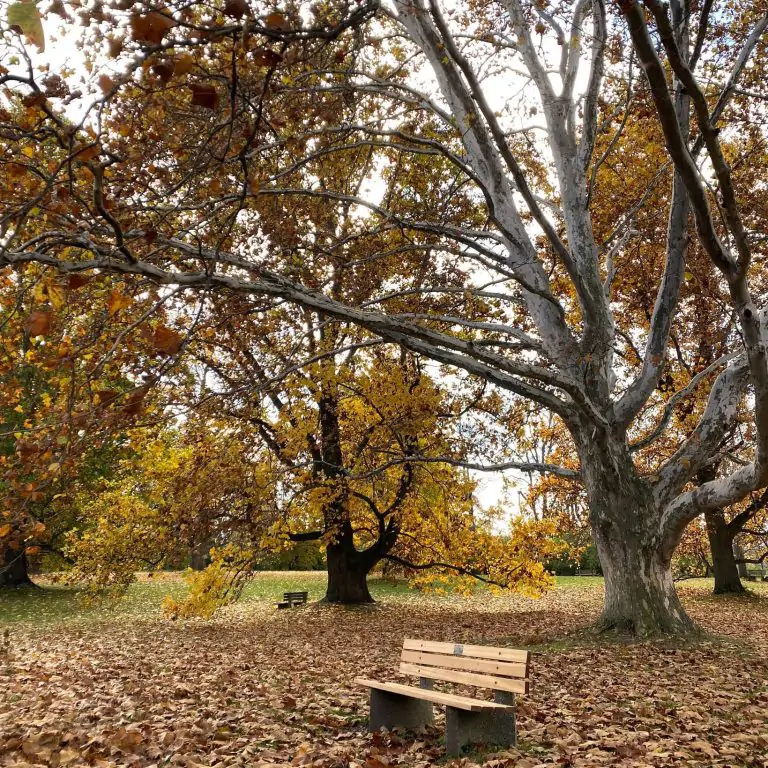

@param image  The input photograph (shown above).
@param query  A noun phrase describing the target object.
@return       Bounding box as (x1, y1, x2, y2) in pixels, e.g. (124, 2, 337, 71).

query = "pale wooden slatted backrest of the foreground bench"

(400, 639, 531, 693)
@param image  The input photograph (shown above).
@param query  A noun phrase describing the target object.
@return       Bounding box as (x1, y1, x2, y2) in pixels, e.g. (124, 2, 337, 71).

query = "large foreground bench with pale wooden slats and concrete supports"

(355, 640, 530, 756)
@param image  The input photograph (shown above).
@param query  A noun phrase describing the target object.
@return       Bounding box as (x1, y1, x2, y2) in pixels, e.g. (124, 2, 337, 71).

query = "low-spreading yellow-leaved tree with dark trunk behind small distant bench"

(66, 357, 563, 615)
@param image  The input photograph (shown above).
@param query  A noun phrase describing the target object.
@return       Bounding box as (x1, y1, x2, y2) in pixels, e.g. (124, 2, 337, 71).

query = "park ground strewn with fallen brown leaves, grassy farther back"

(0, 574, 768, 768)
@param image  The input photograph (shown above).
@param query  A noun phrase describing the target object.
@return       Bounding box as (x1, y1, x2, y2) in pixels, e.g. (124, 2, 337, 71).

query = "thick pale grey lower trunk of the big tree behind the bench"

(579, 431, 697, 637)
